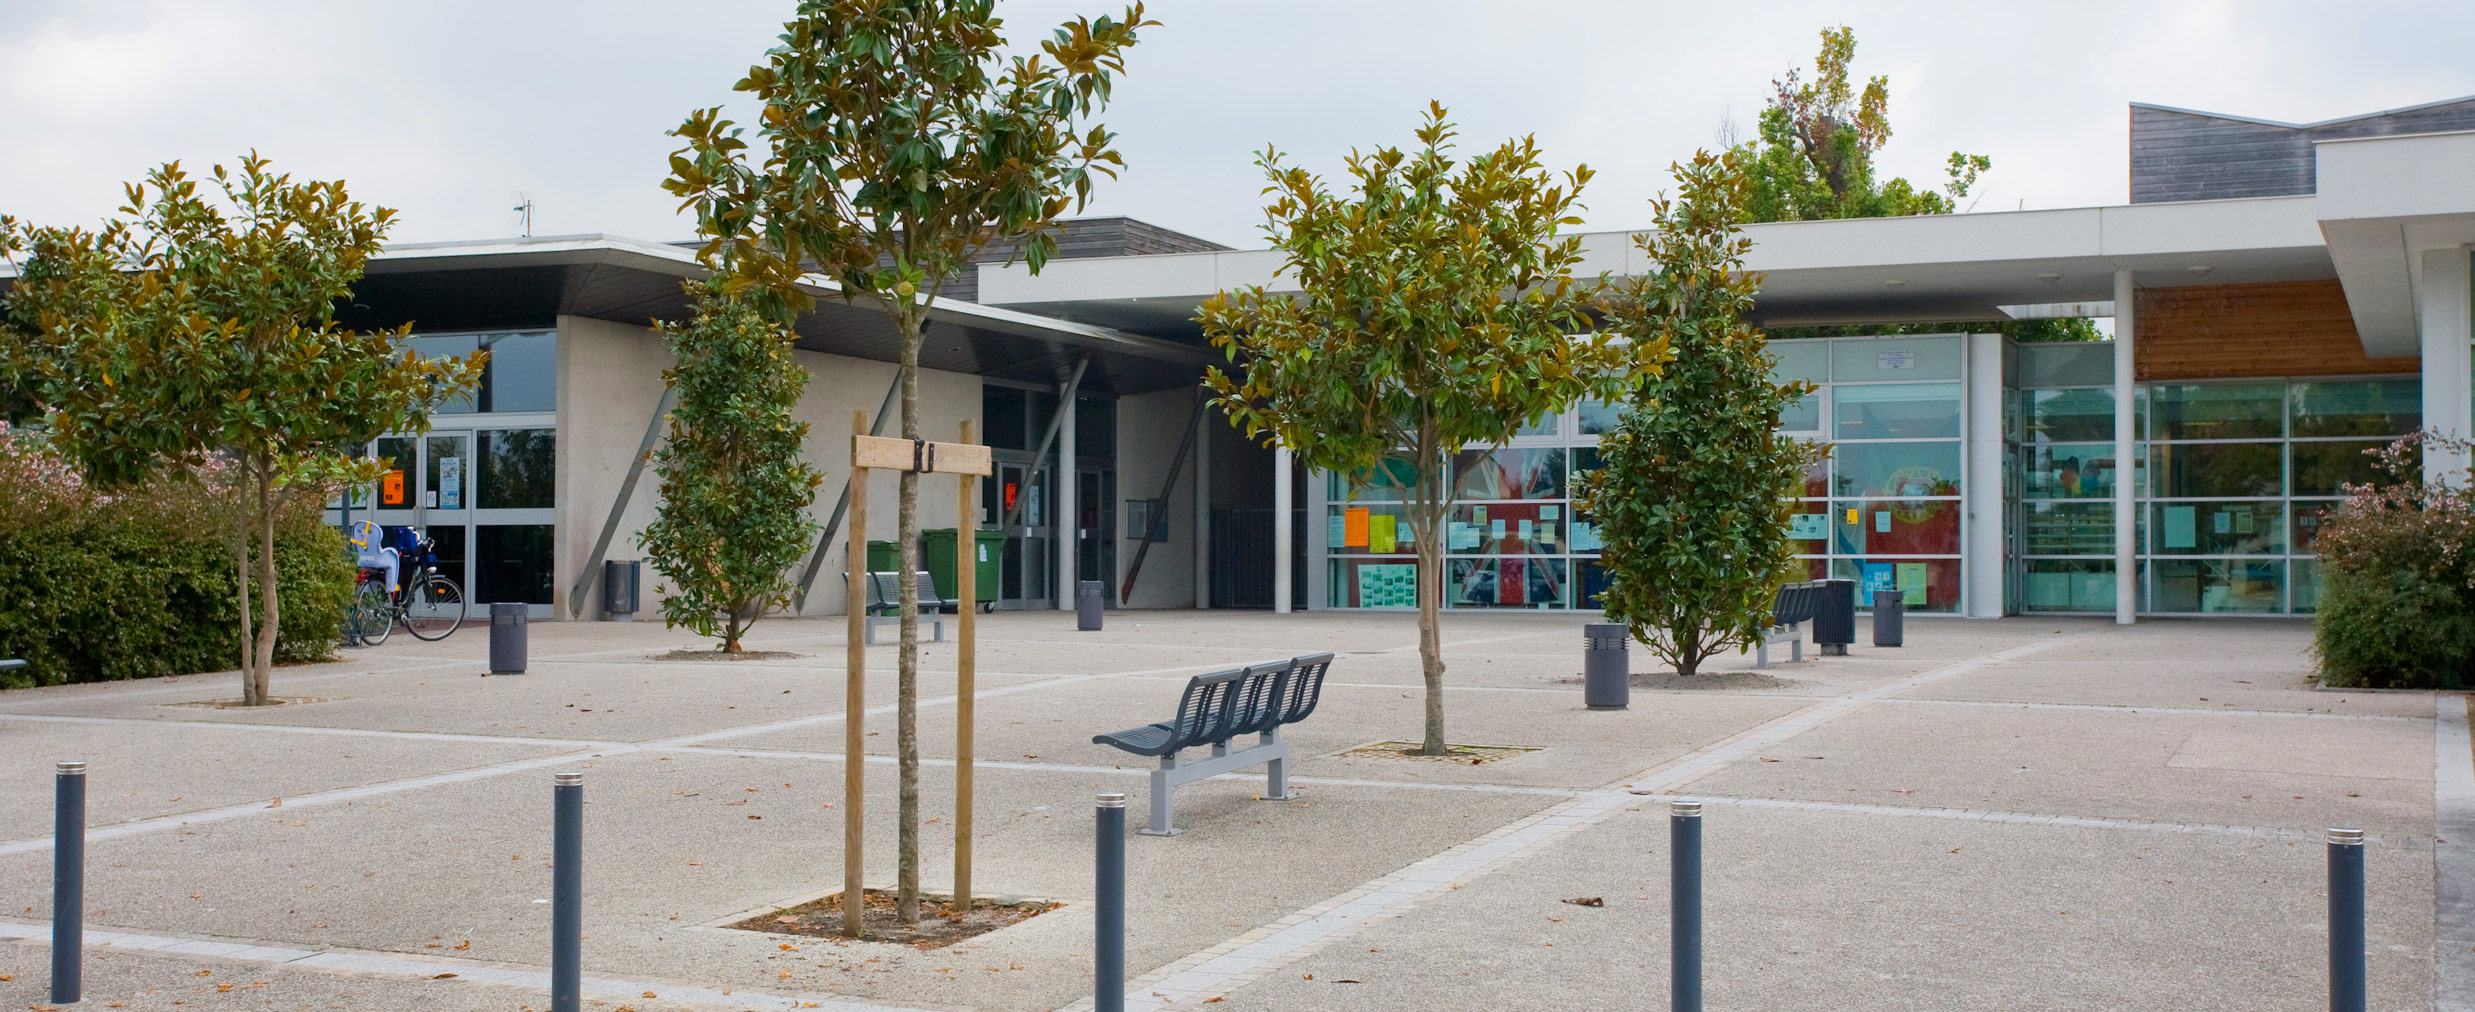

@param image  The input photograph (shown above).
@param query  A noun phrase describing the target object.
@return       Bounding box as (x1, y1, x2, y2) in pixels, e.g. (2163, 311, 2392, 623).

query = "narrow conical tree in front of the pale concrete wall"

(639, 282, 824, 653)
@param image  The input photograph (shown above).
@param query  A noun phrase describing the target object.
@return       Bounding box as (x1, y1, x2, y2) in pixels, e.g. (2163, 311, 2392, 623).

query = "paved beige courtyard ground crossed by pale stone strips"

(0, 611, 2475, 1012)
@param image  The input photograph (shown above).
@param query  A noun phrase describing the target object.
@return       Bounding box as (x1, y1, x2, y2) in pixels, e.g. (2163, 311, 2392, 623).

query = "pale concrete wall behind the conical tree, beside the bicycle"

(552, 317, 980, 621)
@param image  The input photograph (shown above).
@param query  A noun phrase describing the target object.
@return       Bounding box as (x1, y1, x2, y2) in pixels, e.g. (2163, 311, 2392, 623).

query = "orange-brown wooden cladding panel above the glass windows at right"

(2133, 282, 2418, 384)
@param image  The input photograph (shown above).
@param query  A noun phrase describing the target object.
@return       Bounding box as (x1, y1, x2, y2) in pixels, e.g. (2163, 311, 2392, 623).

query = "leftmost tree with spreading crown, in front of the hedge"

(0, 151, 483, 705)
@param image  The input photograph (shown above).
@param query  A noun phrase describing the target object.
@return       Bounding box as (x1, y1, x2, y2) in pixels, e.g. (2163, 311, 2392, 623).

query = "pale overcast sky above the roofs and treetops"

(14, 0, 2475, 247)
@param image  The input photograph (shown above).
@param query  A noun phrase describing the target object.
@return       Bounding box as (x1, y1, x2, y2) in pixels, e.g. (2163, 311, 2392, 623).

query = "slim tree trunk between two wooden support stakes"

(893, 299, 921, 925)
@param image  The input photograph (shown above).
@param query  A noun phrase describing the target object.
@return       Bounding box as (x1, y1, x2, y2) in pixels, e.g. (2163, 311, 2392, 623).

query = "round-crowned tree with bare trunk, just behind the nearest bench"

(1198, 104, 1666, 755)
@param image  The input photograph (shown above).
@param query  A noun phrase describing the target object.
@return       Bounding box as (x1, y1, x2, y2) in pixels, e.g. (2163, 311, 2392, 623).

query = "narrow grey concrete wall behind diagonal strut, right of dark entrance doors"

(1111, 388, 1197, 609)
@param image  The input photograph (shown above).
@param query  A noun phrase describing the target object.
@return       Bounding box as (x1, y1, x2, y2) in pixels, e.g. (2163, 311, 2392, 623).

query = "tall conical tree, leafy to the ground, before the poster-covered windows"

(1574, 151, 1814, 675)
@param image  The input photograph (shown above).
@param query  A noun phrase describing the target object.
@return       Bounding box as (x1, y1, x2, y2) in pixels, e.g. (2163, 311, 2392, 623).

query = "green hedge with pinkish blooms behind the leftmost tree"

(0, 426, 354, 688)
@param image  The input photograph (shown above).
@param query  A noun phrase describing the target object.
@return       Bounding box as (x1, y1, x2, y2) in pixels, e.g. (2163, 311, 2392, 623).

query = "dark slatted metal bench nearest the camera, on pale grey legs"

(1091, 653, 1332, 836)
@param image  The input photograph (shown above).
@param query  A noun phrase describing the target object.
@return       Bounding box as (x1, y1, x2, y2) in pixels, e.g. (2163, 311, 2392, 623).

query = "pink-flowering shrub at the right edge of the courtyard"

(2312, 433, 2475, 688)
